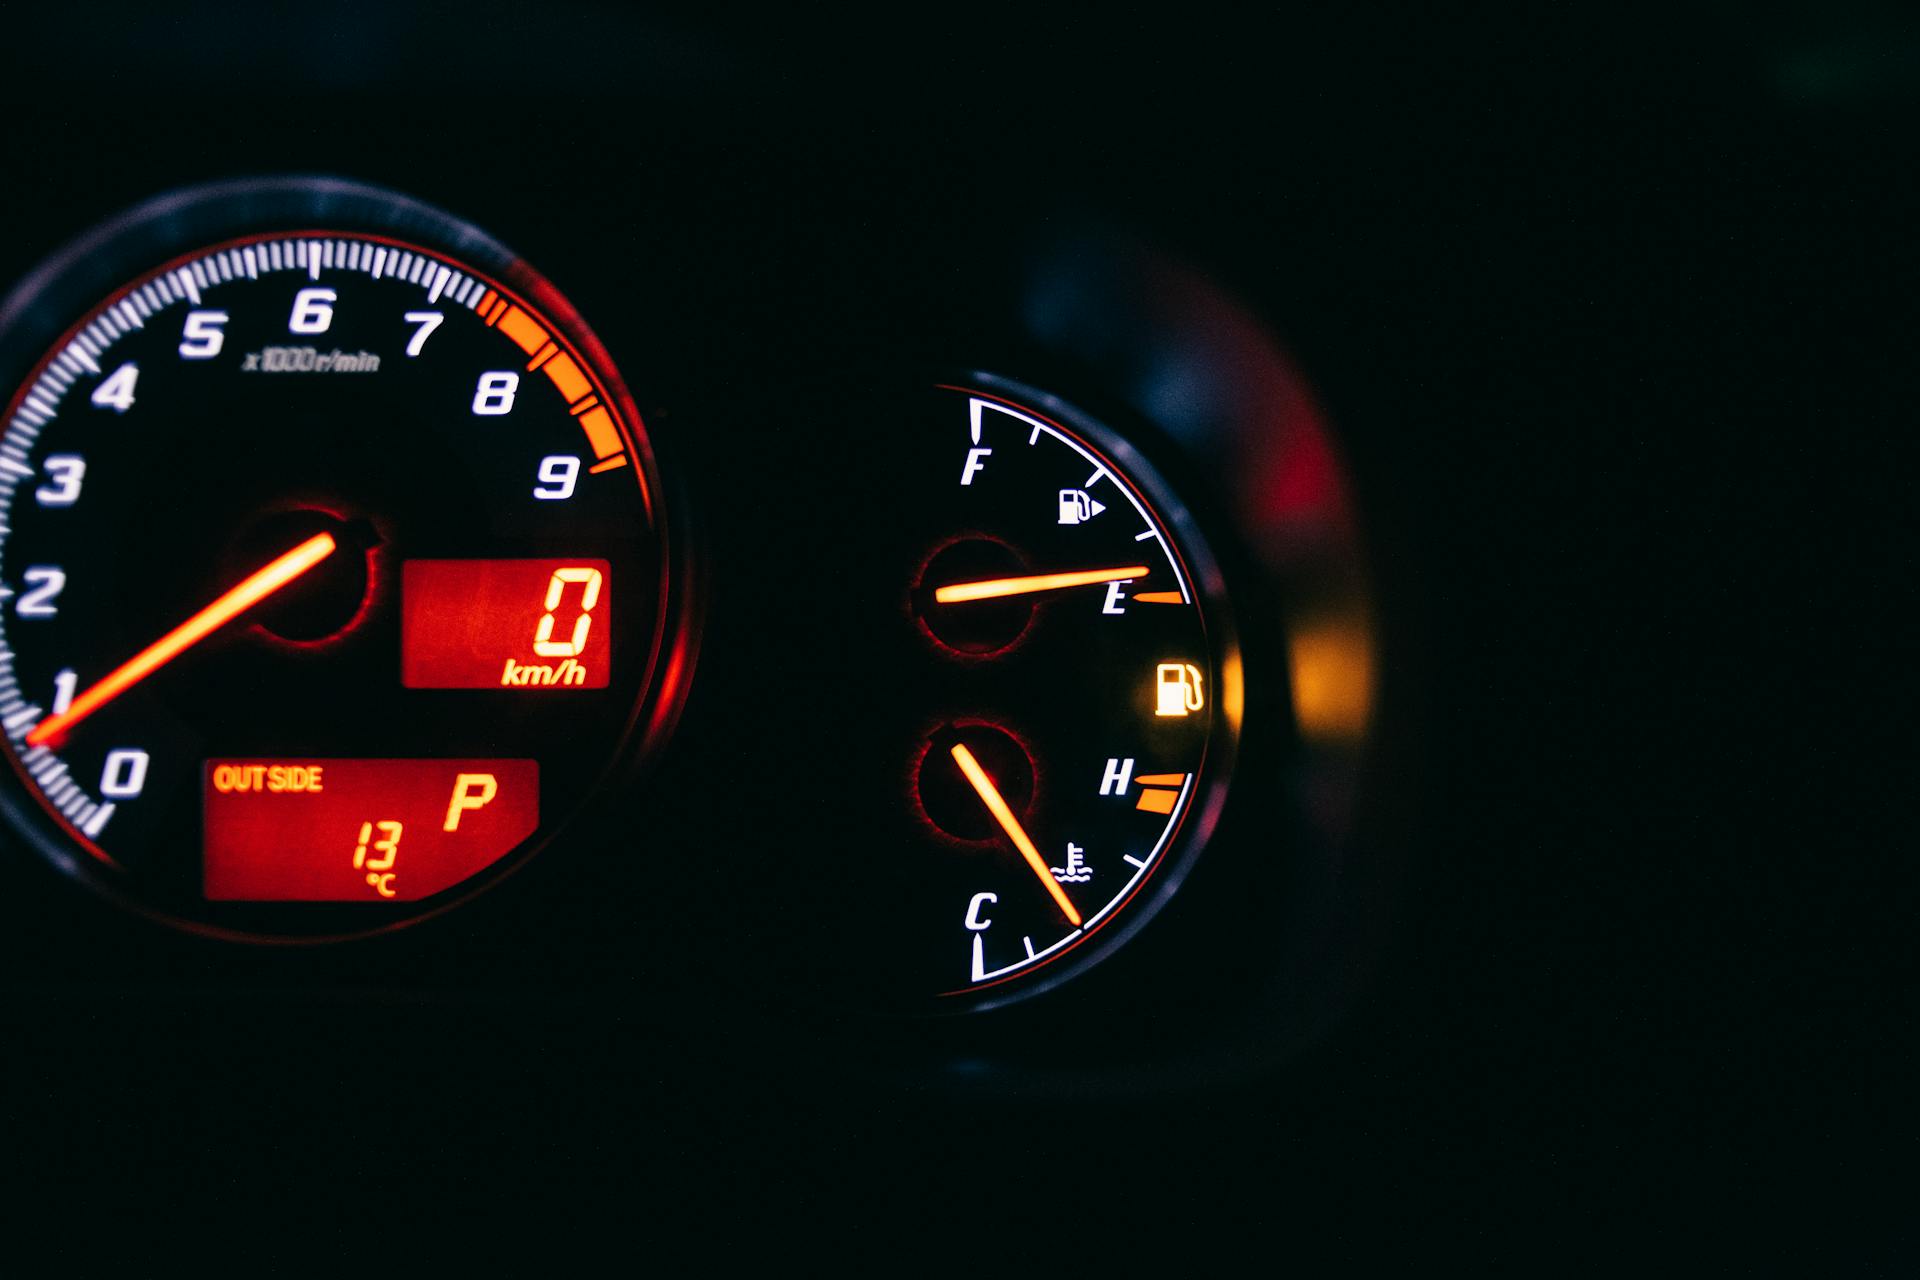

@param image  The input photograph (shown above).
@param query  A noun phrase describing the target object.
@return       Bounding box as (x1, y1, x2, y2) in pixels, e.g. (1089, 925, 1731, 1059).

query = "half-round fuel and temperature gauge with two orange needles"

(908, 380, 1238, 1002)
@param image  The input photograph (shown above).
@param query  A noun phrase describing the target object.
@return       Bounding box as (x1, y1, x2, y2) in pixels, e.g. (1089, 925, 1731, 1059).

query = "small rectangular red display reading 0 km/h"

(399, 560, 612, 691)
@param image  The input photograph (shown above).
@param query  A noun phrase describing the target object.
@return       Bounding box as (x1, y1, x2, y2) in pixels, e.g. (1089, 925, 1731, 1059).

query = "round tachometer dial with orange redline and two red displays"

(0, 182, 674, 936)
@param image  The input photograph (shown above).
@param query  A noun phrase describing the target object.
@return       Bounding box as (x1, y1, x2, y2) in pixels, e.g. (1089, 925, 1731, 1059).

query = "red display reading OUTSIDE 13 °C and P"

(204, 760, 540, 902)
